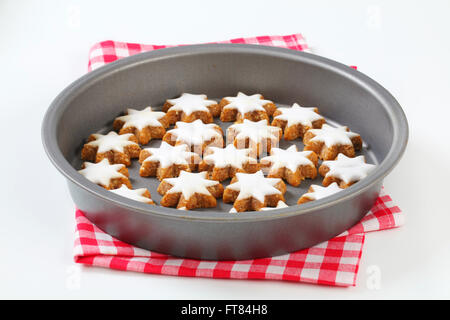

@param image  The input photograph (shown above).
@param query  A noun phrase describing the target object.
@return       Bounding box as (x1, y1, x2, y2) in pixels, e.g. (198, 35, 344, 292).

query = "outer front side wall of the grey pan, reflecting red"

(69, 182, 381, 260)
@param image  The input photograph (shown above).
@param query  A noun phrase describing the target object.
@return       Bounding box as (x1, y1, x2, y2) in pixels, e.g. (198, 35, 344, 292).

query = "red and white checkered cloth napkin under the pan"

(74, 34, 404, 286)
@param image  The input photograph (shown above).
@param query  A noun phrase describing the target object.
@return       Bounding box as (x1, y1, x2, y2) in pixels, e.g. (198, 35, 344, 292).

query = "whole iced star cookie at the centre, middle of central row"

(198, 144, 259, 181)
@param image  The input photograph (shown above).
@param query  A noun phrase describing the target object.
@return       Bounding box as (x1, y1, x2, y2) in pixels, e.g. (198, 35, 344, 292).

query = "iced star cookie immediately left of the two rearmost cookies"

(113, 107, 169, 144)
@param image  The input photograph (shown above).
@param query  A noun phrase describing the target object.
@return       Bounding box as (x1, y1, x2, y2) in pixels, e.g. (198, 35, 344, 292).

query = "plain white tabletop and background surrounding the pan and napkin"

(0, 0, 450, 299)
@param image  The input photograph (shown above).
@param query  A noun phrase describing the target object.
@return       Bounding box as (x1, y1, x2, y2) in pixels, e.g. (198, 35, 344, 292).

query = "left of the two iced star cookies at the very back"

(163, 93, 220, 124)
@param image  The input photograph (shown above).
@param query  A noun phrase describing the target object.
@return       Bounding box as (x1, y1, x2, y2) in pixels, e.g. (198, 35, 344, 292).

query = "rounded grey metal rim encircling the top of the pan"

(41, 44, 409, 223)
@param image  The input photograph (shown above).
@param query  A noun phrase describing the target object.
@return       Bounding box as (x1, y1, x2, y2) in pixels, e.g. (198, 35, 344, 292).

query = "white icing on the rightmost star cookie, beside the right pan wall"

(322, 153, 376, 183)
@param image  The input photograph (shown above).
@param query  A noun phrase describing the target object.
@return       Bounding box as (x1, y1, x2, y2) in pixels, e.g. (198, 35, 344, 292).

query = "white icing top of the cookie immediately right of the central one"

(261, 144, 314, 172)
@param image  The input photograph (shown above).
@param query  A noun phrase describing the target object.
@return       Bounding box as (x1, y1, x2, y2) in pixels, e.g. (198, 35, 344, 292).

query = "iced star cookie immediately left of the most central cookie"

(139, 141, 200, 181)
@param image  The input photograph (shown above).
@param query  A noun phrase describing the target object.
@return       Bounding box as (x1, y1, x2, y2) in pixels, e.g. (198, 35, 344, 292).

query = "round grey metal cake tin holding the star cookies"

(42, 44, 408, 260)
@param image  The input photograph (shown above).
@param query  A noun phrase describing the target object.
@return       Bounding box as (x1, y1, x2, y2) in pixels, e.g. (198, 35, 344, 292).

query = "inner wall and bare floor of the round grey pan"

(54, 46, 395, 216)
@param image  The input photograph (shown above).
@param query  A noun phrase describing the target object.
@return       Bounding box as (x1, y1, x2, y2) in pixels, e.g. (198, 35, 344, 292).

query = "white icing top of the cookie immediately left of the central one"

(143, 141, 198, 168)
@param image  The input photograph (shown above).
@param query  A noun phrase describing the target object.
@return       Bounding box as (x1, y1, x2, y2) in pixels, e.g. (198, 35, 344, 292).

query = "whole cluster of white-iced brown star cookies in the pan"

(79, 92, 374, 212)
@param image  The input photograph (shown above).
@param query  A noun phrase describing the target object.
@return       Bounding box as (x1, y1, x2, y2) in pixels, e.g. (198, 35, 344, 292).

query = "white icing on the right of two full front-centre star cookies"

(227, 170, 281, 202)
